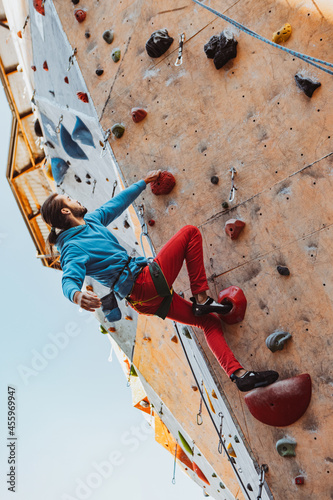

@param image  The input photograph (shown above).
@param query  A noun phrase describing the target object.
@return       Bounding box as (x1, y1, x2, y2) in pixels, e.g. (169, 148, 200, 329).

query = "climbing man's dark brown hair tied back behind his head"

(40, 193, 70, 256)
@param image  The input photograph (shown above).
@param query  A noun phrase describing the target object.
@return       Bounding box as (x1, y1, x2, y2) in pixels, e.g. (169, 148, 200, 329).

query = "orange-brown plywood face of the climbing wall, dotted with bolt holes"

(36, 0, 333, 500)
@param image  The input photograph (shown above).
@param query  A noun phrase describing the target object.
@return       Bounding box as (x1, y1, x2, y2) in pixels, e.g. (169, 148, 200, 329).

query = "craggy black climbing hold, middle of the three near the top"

(204, 30, 238, 69)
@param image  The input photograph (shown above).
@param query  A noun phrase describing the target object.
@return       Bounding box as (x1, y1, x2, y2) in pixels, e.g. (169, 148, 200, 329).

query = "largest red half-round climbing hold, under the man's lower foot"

(245, 373, 311, 427)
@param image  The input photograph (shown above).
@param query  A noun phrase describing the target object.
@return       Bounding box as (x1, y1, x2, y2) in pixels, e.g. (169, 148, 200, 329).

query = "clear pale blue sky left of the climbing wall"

(0, 86, 203, 500)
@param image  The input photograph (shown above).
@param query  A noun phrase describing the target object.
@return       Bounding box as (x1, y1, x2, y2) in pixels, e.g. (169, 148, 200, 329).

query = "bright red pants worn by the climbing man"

(129, 226, 242, 377)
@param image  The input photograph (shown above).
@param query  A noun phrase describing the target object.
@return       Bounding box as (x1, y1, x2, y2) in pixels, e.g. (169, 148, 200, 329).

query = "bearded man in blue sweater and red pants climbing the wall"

(41, 170, 279, 392)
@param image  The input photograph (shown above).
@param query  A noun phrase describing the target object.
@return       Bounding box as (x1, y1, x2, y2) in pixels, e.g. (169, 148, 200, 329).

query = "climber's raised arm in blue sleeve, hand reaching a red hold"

(89, 170, 161, 226)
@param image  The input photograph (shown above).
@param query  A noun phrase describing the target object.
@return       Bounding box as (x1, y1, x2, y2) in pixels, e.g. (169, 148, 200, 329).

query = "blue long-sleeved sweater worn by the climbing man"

(56, 180, 147, 301)
